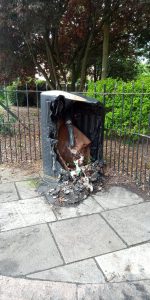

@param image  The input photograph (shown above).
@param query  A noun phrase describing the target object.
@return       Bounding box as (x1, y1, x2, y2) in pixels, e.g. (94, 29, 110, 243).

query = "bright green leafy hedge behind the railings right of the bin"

(88, 76, 150, 135)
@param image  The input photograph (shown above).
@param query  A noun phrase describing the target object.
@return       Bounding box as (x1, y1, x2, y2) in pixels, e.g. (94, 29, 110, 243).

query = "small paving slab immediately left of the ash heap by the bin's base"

(16, 179, 39, 199)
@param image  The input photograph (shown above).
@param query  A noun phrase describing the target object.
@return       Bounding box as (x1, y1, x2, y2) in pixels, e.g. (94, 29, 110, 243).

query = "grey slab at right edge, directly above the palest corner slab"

(102, 202, 150, 245)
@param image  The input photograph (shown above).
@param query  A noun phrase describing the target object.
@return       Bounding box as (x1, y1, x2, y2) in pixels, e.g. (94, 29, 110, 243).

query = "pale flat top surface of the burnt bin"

(42, 90, 99, 104)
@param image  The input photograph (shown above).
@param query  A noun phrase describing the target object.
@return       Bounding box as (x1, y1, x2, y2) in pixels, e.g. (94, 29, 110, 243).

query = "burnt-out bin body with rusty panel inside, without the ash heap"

(41, 91, 105, 177)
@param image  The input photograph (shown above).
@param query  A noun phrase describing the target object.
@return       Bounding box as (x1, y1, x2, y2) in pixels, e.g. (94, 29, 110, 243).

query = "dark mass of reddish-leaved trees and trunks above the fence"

(0, 0, 149, 90)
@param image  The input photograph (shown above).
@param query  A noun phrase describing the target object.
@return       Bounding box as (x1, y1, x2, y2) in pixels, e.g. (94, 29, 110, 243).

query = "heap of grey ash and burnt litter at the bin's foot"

(49, 157, 104, 205)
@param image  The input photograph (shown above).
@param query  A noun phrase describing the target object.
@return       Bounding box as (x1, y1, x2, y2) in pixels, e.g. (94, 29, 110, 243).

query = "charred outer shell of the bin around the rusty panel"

(41, 90, 105, 178)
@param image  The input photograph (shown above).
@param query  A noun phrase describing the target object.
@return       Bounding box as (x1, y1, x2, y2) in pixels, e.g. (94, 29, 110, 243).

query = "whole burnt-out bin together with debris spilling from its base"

(41, 91, 104, 203)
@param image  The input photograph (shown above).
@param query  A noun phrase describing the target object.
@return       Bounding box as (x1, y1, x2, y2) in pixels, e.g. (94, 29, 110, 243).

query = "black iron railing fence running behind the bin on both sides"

(0, 84, 150, 188)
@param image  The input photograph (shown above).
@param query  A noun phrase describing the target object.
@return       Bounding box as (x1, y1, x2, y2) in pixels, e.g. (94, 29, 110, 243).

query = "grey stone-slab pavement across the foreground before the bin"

(0, 178, 150, 300)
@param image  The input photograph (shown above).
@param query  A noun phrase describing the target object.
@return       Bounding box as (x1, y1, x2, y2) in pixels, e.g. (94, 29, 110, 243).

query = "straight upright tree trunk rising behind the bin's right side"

(101, 23, 109, 79)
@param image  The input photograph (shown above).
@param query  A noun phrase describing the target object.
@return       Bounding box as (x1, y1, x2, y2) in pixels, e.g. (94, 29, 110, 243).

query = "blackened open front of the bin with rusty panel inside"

(49, 95, 103, 171)
